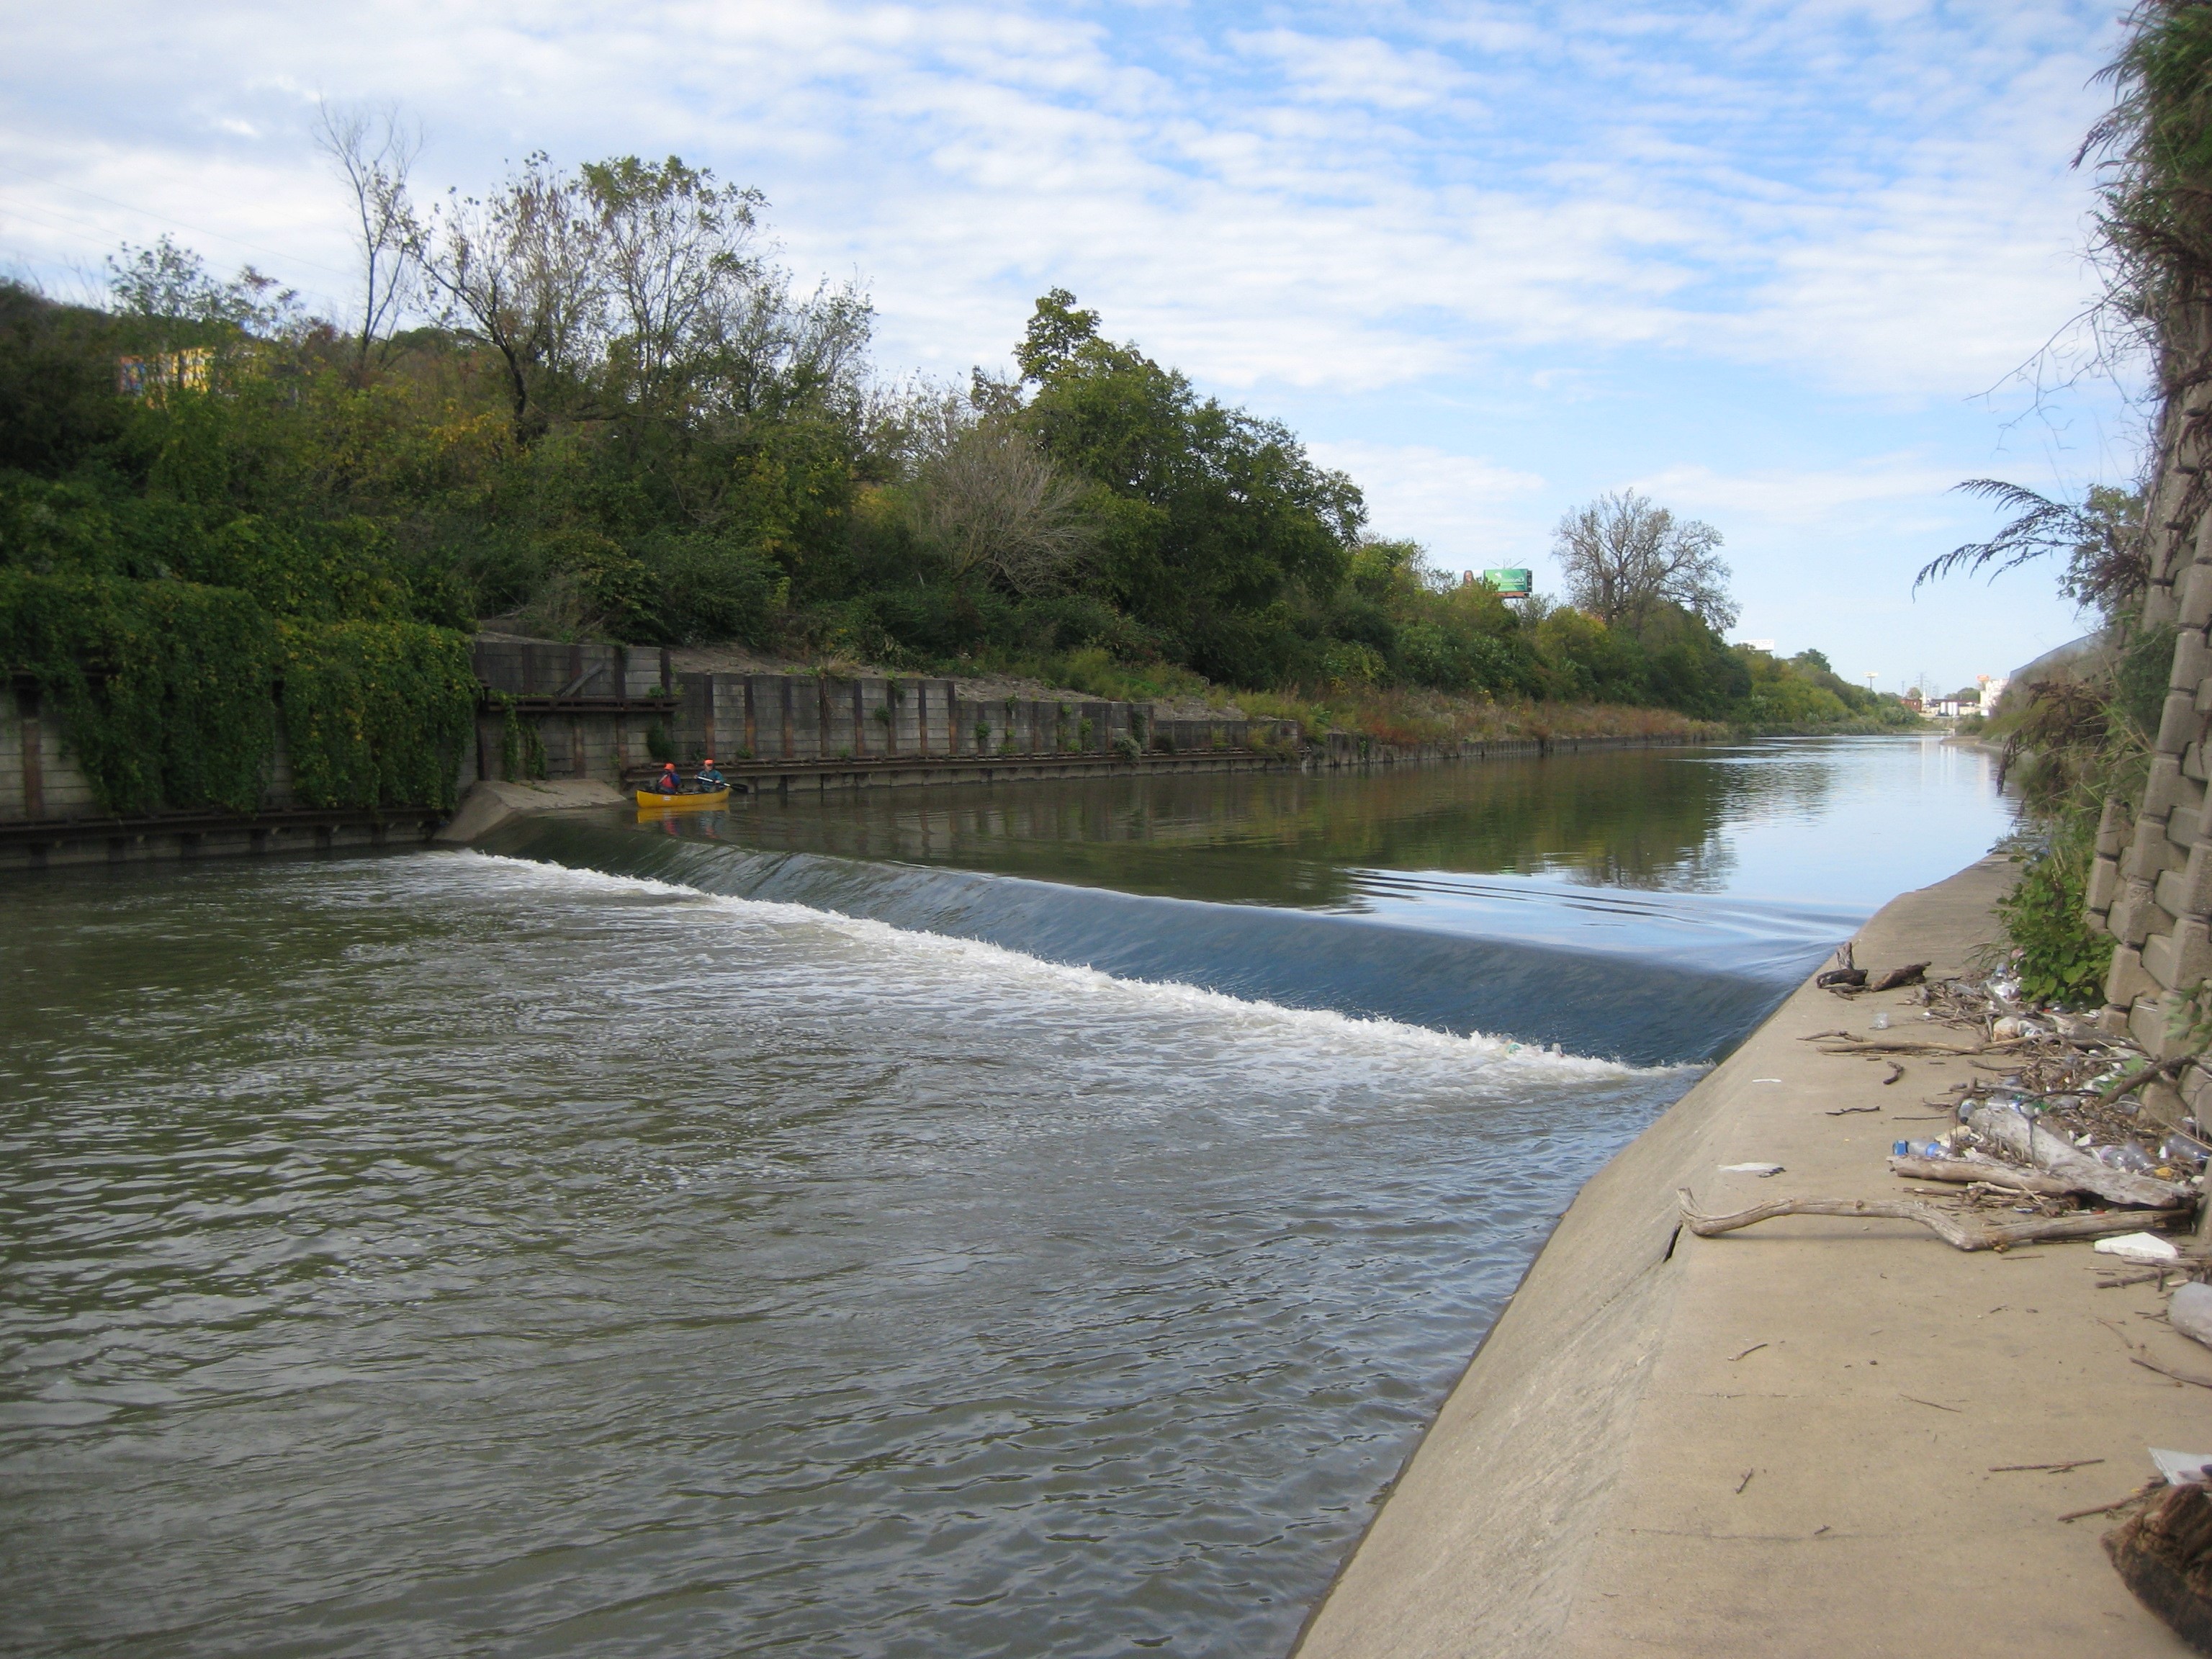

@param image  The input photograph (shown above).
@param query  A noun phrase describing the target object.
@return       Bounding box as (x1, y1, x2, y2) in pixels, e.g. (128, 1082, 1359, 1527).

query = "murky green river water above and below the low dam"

(0, 739, 2006, 1655)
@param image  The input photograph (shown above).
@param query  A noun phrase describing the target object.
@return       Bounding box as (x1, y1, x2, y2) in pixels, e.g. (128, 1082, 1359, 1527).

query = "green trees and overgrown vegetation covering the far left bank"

(0, 135, 1913, 809)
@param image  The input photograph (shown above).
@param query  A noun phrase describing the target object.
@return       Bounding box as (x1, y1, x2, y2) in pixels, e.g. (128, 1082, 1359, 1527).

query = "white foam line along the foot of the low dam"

(436, 852, 1672, 1079)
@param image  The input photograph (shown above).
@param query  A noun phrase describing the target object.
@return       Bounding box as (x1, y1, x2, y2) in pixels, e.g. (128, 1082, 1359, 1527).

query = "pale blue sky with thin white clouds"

(0, 0, 2144, 690)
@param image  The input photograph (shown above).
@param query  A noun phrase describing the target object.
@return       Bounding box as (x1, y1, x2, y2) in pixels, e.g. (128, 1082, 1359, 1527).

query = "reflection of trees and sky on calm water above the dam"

(675, 737, 2006, 914)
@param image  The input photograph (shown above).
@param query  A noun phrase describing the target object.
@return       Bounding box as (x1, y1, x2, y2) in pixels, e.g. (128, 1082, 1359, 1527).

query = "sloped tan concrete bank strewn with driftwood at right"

(1296, 858, 2212, 1659)
